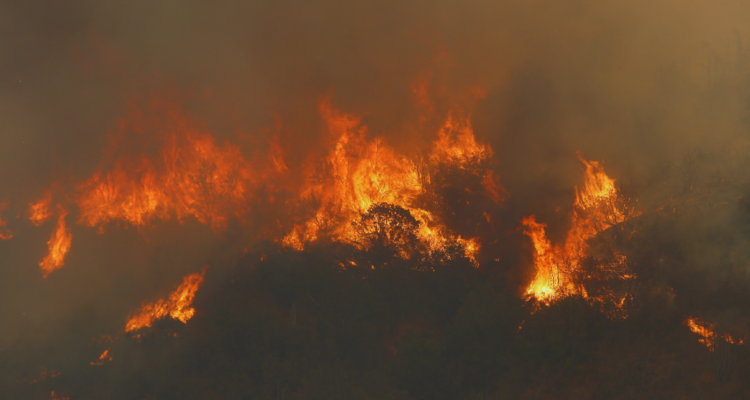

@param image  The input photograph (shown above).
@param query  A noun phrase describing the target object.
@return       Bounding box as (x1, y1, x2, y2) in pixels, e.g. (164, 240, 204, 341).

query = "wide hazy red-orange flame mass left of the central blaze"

(77, 95, 286, 231)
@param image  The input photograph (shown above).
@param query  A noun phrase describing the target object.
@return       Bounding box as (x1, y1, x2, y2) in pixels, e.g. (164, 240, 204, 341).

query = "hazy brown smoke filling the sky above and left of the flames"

(0, 0, 750, 366)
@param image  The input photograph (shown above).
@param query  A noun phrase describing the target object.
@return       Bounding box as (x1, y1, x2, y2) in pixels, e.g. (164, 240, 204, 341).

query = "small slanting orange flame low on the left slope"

(125, 267, 207, 332)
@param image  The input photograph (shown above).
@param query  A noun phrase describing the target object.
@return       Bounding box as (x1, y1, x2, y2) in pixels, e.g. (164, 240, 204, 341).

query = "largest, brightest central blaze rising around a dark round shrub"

(282, 99, 505, 258)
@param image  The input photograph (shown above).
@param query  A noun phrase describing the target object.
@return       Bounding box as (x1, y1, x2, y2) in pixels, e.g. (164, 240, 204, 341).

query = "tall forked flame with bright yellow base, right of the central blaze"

(521, 154, 640, 308)
